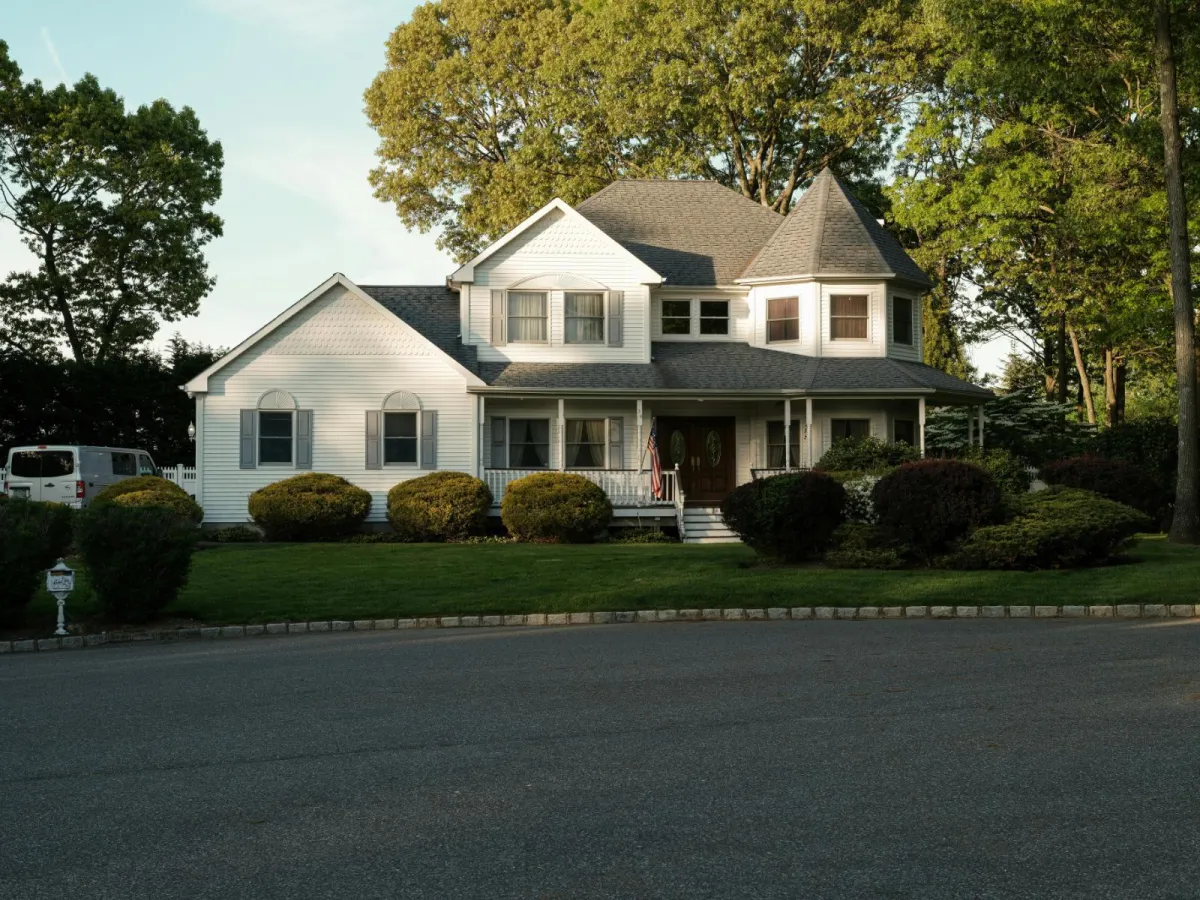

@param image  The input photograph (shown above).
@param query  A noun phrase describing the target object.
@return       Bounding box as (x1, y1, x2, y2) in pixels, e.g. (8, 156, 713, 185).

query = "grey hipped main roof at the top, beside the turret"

(578, 179, 785, 286)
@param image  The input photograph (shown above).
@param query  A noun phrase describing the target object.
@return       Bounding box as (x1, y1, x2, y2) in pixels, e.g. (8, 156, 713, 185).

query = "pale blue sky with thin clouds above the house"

(0, 0, 1008, 371)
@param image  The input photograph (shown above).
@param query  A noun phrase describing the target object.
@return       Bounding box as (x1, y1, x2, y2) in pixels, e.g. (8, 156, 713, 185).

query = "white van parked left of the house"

(4, 444, 161, 509)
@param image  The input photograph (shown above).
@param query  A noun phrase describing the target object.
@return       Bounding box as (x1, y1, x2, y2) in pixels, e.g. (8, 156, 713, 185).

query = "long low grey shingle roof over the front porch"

(479, 341, 992, 400)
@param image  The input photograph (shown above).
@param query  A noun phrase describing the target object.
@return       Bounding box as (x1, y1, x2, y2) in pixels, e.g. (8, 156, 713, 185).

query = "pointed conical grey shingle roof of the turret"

(740, 168, 931, 287)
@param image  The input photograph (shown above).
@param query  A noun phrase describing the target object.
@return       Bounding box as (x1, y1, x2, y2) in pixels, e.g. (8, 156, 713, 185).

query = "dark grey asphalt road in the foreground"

(0, 620, 1200, 900)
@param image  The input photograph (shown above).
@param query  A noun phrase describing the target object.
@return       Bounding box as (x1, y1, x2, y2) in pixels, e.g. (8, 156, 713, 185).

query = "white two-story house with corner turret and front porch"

(184, 170, 991, 538)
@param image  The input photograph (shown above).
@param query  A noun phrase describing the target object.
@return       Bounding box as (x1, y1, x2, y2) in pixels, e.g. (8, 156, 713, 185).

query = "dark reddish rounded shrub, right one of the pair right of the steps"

(871, 460, 1003, 562)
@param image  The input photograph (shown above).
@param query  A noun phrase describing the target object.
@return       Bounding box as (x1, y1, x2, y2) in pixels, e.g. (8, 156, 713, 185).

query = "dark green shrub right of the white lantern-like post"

(76, 503, 199, 623)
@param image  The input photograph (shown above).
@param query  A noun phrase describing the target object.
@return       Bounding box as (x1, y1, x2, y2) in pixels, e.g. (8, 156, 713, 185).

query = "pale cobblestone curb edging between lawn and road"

(0, 604, 1200, 654)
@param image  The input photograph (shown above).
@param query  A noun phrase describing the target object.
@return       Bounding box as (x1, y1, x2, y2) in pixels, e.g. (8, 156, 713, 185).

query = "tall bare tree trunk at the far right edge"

(1154, 0, 1200, 544)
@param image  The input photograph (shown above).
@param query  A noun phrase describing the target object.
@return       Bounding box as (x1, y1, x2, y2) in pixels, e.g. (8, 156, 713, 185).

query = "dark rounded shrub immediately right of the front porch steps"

(721, 472, 846, 563)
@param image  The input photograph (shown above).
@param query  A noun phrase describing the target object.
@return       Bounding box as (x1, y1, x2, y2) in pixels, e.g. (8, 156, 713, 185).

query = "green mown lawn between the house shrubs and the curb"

(21, 538, 1200, 626)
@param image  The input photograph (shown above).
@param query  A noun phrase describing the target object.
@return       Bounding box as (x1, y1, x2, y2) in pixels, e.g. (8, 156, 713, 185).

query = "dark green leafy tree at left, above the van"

(0, 42, 222, 362)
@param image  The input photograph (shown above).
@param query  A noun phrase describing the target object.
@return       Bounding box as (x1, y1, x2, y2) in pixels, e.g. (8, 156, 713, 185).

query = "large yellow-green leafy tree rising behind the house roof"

(366, 0, 929, 258)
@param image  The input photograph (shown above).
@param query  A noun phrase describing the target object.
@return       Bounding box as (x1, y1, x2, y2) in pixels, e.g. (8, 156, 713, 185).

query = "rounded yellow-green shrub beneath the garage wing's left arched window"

(250, 472, 371, 541)
